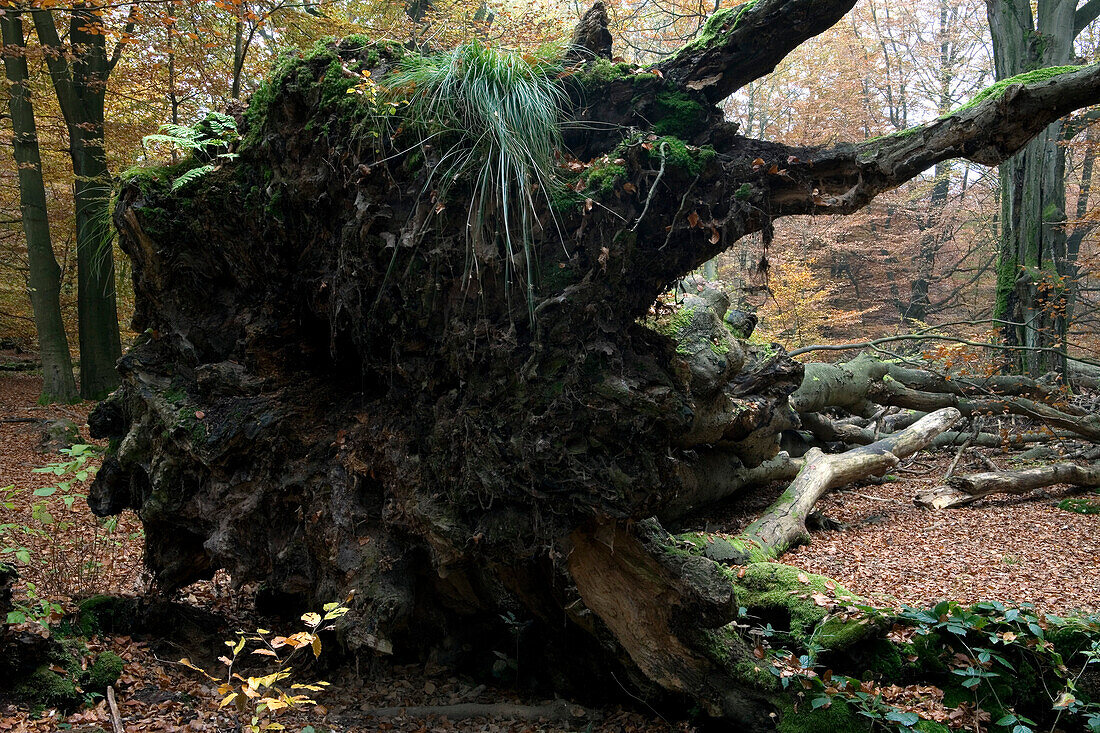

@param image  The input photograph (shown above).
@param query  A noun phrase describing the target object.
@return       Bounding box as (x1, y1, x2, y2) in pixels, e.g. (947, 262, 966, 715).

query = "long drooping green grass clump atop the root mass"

(385, 42, 565, 319)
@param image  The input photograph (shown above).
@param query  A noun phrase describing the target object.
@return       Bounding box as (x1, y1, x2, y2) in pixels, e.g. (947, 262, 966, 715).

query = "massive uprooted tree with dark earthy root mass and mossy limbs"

(89, 0, 1100, 730)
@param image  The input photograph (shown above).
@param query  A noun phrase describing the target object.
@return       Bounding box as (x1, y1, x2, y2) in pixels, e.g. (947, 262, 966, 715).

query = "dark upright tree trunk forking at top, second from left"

(33, 3, 122, 400)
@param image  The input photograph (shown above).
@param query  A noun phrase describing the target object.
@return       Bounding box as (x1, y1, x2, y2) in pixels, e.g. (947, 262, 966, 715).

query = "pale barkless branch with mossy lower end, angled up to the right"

(707, 407, 960, 565)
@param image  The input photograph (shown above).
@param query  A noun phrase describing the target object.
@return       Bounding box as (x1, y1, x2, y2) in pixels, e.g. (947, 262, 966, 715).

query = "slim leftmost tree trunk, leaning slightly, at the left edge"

(0, 10, 77, 402)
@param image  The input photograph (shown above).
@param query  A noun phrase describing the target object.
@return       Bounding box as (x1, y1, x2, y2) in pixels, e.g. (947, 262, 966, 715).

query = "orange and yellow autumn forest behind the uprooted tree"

(0, 0, 1100, 372)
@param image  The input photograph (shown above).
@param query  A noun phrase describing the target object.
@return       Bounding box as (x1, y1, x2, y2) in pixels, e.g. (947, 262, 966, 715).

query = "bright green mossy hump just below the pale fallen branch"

(736, 562, 872, 649)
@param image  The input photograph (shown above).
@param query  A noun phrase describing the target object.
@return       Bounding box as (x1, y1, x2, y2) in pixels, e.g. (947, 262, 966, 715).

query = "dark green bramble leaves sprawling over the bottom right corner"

(738, 601, 1100, 733)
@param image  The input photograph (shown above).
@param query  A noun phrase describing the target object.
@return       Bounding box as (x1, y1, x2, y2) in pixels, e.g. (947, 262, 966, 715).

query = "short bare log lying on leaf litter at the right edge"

(913, 462, 1100, 510)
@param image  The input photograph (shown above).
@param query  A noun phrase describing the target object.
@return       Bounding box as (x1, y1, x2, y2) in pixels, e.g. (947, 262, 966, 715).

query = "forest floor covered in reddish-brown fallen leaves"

(0, 373, 1100, 733)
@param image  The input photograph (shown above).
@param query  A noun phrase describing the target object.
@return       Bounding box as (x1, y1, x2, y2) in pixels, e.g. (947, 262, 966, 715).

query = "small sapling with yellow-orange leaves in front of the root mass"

(179, 595, 351, 733)
